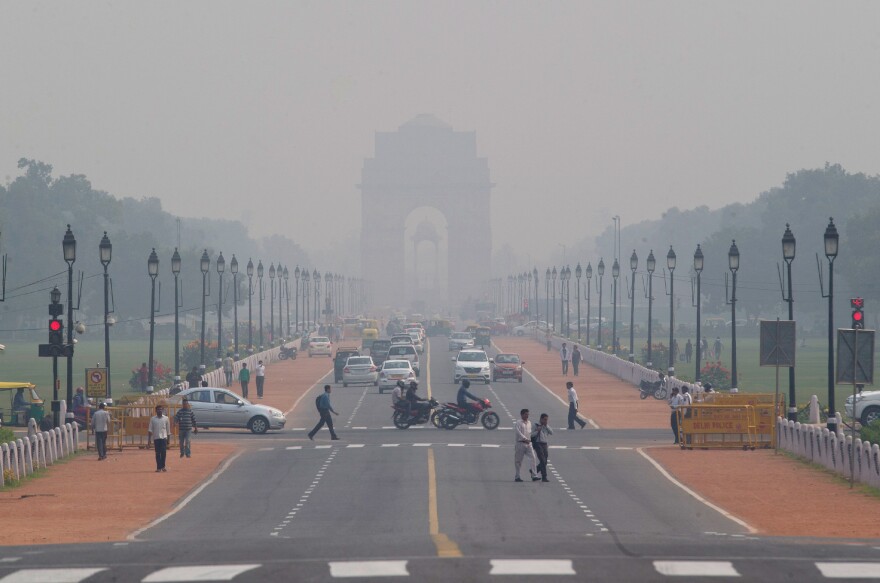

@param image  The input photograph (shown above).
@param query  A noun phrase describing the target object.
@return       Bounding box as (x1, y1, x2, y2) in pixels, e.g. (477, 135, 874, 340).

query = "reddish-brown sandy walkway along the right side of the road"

(494, 337, 880, 539)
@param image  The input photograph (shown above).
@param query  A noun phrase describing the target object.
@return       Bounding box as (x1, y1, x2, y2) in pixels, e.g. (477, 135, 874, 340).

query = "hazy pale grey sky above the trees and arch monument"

(0, 0, 880, 264)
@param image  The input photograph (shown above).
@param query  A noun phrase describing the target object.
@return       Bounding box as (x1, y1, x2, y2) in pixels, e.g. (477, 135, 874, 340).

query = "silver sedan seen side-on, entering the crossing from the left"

(168, 387, 287, 433)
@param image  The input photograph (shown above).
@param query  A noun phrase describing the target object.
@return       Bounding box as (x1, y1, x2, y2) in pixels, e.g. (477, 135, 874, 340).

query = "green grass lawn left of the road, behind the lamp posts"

(0, 338, 179, 400)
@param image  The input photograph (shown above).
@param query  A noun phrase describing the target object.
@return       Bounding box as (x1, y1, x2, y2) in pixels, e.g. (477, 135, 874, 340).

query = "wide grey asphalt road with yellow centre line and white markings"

(0, 337, 880, 583)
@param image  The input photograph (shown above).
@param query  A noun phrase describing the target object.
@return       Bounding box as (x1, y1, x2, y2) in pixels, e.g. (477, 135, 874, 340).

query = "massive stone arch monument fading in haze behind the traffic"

(359, 114, 493, 308)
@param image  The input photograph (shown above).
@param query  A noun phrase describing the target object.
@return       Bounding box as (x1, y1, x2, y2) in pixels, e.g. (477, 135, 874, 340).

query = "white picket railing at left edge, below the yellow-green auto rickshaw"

(0, 423, 80, 486)
